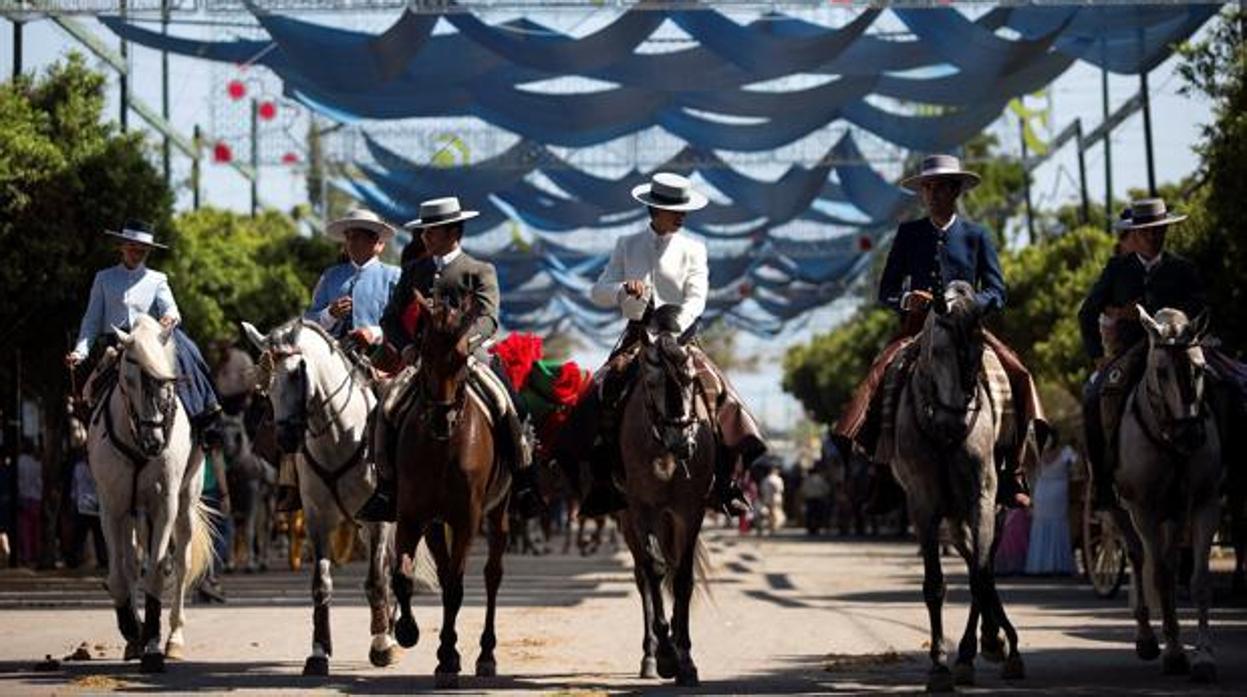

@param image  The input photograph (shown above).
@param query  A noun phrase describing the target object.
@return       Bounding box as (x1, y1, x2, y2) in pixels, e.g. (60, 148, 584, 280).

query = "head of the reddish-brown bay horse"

(416, 292, 479, 440)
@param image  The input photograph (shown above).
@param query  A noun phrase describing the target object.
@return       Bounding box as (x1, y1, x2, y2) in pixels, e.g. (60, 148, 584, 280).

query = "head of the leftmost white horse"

(113, 315, 177, 458)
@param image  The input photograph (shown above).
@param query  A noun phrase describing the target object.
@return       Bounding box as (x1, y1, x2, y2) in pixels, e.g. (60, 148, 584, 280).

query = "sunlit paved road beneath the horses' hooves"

(0, 531, 1247, 695)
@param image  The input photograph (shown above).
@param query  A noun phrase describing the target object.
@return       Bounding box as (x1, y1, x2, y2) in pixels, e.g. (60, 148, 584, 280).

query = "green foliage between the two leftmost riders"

(162, 208, 337, 342)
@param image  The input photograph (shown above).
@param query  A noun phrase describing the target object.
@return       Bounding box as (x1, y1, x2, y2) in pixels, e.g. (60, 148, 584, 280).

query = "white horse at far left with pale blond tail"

(87, 315, 212, 672)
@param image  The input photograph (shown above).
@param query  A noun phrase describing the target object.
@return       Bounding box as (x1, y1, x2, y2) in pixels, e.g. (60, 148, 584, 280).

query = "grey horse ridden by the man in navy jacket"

(888, 281, 1024, 692)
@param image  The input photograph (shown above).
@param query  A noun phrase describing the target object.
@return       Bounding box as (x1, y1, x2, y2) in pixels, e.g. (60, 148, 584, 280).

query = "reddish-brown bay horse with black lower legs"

(392, 293, 510, 688)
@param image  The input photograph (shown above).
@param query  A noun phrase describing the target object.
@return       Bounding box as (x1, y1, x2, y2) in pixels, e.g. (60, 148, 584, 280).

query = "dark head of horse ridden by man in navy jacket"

(922, 281, 983, 441)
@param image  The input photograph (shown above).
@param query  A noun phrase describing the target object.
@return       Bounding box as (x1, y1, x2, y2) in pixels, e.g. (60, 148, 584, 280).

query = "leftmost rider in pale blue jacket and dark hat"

(65, 221, 221, 445)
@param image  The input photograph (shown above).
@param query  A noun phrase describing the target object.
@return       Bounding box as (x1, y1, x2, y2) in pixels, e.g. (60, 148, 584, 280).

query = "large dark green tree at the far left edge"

(0, 54, 172, 395)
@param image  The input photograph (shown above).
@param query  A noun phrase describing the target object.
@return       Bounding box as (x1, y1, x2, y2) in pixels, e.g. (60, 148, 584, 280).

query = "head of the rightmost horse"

(1139, 307, 1208, 450)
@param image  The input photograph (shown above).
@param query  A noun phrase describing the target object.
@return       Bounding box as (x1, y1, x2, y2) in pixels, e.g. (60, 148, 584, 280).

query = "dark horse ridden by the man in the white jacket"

(619, 336, 716, 687)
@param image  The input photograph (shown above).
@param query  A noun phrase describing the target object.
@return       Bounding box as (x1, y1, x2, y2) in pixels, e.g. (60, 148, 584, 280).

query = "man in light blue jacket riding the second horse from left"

(277, 208, 399, 511)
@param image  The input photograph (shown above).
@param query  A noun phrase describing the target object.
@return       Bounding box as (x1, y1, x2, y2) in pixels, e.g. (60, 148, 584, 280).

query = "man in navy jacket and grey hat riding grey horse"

(834, 155, 1047, 507)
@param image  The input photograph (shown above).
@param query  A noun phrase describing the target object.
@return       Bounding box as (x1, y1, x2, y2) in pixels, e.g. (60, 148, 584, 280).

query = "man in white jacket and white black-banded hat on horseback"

(577, 172, 767, 517)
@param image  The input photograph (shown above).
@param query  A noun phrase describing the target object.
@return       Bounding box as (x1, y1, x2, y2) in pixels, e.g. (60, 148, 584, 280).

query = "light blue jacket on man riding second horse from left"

(306, 257, 400, 340)
